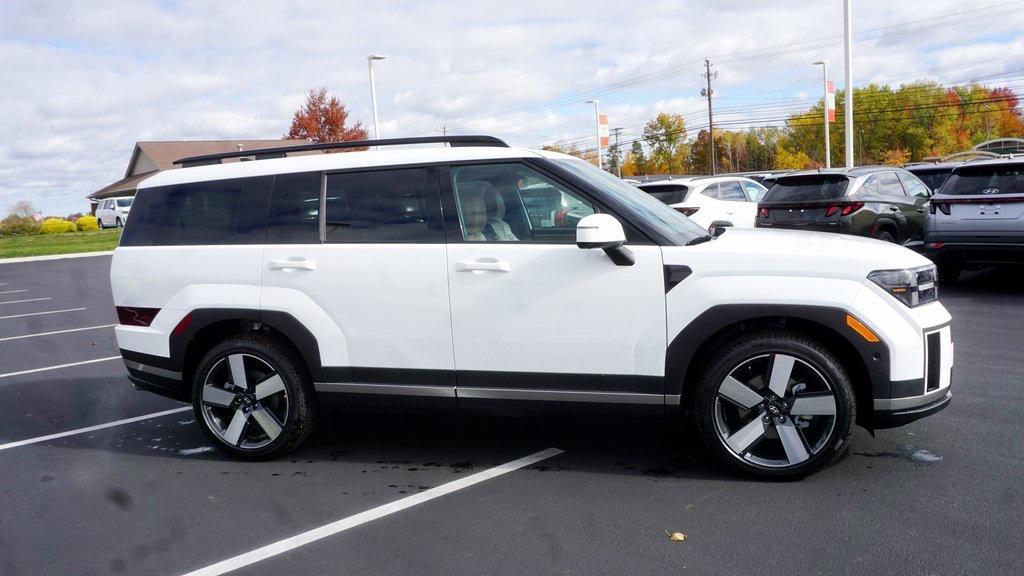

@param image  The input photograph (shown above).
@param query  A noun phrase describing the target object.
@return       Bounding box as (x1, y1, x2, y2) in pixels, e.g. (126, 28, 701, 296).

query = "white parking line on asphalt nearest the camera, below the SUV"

(184, 448, 562, 576)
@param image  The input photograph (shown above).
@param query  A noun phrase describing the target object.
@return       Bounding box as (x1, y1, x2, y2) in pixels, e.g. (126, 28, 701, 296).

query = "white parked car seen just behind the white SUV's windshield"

(637, 176, 768, 230)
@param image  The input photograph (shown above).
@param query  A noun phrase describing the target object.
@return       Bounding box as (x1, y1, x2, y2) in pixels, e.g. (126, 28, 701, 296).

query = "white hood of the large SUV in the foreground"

(664, 228, 931, 279)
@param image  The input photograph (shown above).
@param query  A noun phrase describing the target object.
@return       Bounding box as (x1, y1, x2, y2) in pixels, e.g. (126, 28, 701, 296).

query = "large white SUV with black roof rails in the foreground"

(111, 136, 953, 476)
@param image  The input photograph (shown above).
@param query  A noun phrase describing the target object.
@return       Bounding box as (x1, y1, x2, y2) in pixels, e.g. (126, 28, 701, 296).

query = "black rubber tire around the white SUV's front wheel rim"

(693, 330, 857, 479)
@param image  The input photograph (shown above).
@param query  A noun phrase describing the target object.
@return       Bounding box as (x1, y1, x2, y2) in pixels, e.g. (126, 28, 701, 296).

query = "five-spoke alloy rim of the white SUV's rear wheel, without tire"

(201, 354, 289, 450)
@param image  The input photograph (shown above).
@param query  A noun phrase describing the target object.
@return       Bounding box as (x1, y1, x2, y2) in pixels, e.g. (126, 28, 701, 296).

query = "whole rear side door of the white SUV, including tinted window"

(262, 162, 455, 393)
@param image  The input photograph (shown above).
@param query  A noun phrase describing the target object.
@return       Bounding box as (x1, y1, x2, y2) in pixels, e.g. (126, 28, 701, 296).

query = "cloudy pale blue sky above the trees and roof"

(0, 0, 1024, 216)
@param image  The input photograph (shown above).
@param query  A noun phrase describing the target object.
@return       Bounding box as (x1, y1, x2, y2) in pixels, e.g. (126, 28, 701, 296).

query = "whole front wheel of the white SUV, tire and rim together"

(694, 330, 856, 478)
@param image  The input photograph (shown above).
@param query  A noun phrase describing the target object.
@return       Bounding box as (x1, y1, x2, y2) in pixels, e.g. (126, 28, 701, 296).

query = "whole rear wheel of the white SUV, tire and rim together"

(193, 333, 315, 460)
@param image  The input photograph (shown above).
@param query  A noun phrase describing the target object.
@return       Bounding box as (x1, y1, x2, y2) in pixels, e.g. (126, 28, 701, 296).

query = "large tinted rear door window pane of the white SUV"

(325, 167, 444, 244)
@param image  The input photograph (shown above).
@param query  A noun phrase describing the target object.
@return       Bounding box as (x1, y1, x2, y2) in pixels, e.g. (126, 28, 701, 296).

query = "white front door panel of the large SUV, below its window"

(447, 243, 667, 385)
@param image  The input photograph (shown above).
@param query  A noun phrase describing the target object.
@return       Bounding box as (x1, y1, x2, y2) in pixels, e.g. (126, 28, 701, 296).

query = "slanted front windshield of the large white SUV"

(553, 158, 708, 245)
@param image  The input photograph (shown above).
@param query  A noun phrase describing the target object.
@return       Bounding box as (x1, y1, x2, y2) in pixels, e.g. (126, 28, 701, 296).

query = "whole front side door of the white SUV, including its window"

(444, 164, 666, 393)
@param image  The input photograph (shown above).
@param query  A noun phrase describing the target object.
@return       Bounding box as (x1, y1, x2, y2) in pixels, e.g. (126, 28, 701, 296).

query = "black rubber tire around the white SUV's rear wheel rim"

(193, 332, 317, 460)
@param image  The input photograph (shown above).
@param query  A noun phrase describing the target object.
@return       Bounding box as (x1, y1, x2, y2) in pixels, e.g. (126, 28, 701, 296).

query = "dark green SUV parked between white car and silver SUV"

(756, 166, 931, 246)
